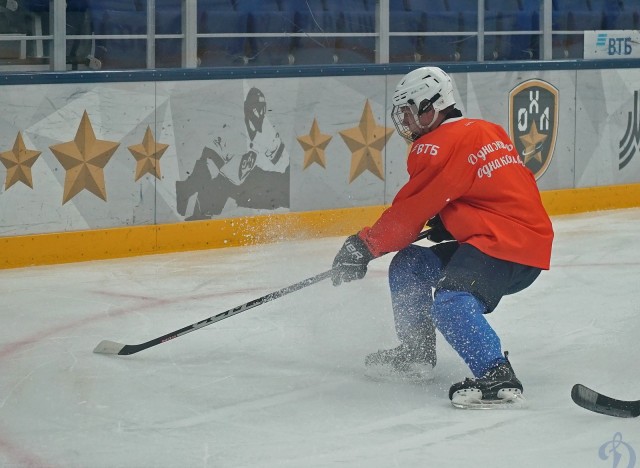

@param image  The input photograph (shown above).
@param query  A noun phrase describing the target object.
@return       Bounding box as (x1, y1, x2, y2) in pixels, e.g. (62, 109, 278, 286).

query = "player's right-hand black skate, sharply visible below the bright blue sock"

(449, 352, 524, 409)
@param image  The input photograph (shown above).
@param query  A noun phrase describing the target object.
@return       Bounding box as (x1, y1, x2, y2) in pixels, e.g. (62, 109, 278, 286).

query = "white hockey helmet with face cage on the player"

(391, 67, 456, 142)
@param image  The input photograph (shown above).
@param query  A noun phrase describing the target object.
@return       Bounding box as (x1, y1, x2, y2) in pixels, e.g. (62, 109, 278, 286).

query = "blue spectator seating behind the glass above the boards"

(25, 0, 640, 69)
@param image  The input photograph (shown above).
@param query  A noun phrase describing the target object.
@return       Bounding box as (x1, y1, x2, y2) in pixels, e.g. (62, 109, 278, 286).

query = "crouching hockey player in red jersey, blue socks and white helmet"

(332, 67, 553, 406)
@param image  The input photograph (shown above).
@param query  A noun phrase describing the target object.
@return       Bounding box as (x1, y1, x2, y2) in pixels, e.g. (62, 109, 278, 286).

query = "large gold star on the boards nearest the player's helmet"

(340, 100, 394, 183)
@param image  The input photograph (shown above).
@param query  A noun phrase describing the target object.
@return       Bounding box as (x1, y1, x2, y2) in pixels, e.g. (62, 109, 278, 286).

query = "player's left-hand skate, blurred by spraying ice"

(364, 343, 436, 383)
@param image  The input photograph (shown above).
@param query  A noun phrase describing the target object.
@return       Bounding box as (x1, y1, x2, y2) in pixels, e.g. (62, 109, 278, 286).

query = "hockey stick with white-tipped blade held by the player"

(93, 230, 429, 356)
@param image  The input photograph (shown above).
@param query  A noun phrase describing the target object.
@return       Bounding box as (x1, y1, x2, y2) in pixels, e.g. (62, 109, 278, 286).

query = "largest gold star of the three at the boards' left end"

(50, 111, 120, 205)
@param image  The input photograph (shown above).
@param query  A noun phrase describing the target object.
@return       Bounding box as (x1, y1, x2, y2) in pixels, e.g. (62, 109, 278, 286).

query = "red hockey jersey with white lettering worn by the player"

(360, 117, 553, 270)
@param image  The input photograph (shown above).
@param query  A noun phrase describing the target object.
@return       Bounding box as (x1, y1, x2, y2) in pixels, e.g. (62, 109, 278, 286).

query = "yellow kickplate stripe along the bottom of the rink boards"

(0, 184, 640, 269)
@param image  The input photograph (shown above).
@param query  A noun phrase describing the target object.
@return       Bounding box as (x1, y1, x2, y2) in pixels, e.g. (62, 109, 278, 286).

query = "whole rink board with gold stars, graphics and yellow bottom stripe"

(0, 68, 640, 267)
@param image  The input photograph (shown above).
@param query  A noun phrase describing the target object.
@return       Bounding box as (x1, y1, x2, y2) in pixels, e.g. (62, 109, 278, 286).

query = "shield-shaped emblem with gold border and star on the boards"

(509, 80, 559, 180)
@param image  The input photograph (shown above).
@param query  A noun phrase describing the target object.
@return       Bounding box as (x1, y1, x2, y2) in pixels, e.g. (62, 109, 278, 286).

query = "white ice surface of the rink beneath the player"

(0, 209, 640, 468)
